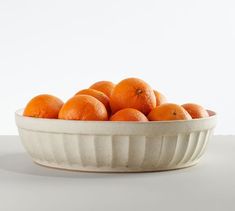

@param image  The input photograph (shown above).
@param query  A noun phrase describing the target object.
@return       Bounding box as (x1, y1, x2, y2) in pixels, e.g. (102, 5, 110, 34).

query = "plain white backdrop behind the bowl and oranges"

(0, 0, 235, 134)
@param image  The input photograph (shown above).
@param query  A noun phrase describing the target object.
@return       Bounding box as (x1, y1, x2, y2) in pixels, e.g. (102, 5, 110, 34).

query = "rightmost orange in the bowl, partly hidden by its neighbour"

(182, 103, 209, 119)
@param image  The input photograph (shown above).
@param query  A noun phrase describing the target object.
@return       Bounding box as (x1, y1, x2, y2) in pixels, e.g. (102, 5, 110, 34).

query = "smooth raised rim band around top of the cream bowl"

(15, 109, 217, 135)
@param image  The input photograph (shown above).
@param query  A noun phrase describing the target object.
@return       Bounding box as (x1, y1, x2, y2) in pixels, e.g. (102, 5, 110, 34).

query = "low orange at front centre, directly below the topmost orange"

(110, 108, 148, 122)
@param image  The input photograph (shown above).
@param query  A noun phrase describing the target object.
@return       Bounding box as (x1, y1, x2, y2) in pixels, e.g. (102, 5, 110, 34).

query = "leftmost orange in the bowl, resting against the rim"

(23, 94, 63, 119)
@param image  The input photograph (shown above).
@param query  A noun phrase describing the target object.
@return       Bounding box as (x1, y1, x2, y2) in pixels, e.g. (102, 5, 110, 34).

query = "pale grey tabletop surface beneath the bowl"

(0, 136, 235, 211)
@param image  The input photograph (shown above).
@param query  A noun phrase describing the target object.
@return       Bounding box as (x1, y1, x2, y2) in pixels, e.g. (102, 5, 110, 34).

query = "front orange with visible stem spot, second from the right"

(148, 103, 192, 121)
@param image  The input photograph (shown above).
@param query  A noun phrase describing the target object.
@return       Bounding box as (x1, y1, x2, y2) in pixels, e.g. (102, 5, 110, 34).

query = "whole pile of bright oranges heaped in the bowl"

(24, 78, 209, 122)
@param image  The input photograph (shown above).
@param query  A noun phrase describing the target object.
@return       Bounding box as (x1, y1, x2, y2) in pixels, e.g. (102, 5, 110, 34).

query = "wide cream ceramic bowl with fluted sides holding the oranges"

(15, 110, 216, 172)
